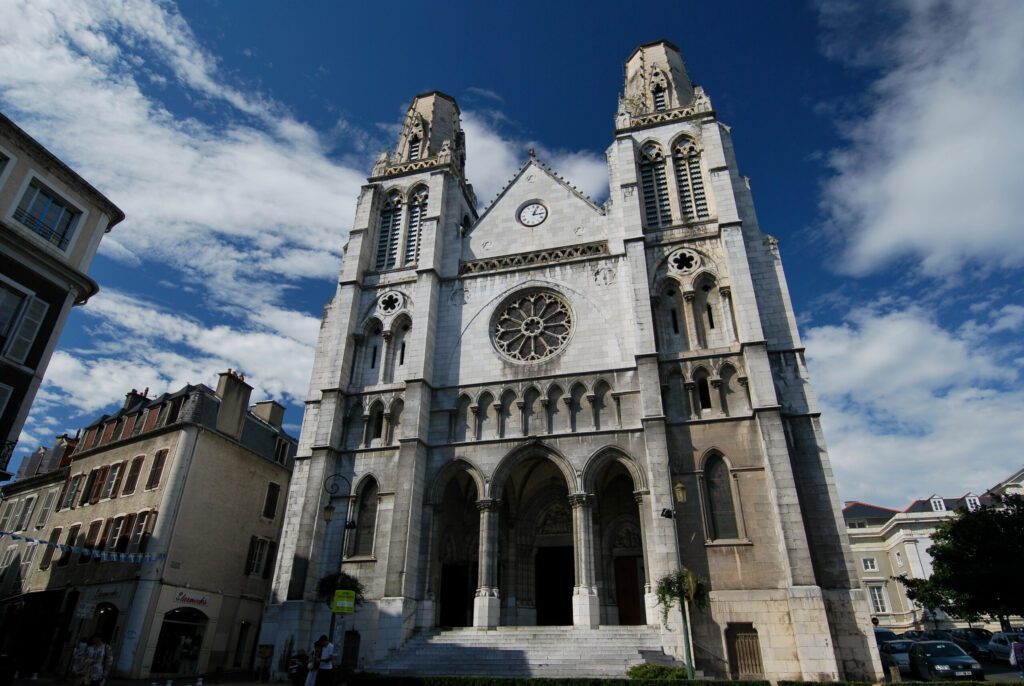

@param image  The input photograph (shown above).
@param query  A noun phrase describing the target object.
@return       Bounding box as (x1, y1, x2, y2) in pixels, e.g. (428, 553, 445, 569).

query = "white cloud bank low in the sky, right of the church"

(805, 307, 1024, 508)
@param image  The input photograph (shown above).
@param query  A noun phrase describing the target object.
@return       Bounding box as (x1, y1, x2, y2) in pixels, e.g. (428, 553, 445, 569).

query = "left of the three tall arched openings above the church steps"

(432, 469, 480, 627)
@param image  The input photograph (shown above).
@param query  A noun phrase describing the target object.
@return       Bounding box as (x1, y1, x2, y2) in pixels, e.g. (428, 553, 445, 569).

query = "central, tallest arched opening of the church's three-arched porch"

(498, 454, 577, 626)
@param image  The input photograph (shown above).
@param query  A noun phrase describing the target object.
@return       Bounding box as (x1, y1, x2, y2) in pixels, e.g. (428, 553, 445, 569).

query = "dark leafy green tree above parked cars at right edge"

(896, 496, 1024, 625)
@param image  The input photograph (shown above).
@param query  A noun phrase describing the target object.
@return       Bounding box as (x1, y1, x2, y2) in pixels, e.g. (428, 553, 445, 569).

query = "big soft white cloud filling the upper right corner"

(822, 0, 1024, 277)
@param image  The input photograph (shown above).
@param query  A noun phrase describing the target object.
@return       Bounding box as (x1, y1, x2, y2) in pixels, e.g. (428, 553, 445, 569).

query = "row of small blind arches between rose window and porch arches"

(449, 379, 623, 442)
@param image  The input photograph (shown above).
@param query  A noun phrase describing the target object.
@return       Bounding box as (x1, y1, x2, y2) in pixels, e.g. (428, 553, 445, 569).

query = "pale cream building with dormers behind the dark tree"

(843, 494, 995, 633)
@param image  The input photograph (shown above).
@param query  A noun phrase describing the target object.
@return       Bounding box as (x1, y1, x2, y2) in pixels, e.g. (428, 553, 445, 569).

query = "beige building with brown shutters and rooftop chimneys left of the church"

(0, 371, 296, 678)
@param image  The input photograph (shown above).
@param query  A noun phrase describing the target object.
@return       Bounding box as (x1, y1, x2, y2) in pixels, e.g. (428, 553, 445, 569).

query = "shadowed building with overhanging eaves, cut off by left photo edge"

(0, 115, 125, 480)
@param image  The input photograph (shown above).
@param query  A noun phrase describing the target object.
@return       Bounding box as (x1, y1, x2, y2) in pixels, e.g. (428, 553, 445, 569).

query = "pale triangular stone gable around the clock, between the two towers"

(462, 158, 607, 262)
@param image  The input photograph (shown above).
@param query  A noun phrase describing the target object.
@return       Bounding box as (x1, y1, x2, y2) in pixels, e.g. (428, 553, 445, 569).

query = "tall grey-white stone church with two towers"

(261, 41, 880, 680)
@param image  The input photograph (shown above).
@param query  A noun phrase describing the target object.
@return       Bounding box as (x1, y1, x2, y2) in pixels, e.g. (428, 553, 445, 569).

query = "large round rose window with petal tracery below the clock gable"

(494, 291, 572, 361)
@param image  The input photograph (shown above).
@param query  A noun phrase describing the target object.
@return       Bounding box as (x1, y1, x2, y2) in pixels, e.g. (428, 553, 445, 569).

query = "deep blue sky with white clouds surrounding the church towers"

(0, 0, 1024, 507)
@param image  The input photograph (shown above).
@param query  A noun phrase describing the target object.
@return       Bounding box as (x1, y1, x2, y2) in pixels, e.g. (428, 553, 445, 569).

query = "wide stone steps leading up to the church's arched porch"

(365, 627, 672, 677)
